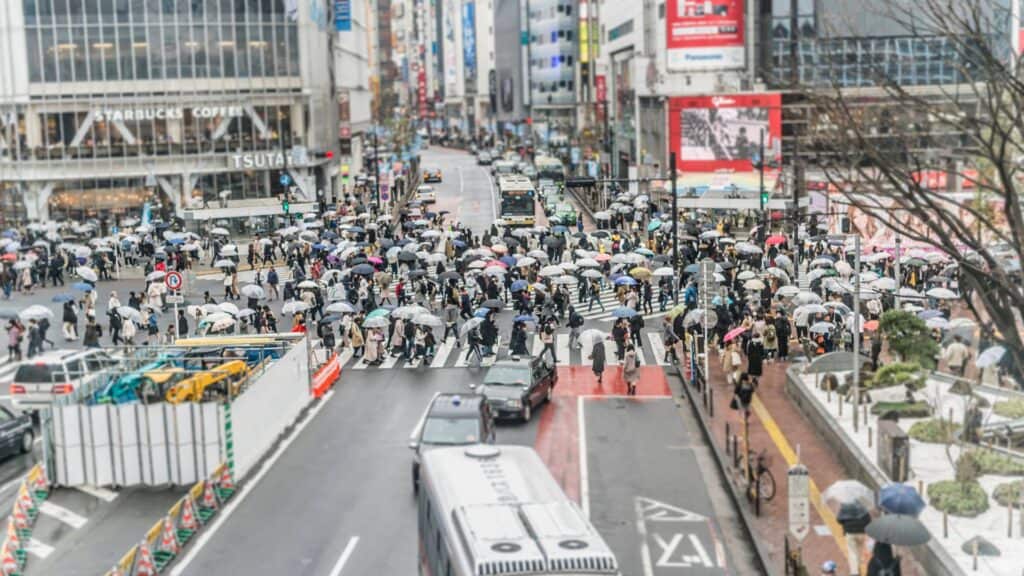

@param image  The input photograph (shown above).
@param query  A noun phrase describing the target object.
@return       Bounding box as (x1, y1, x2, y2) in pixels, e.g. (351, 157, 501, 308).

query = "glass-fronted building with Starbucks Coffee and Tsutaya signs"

(0, 0, 337, 227)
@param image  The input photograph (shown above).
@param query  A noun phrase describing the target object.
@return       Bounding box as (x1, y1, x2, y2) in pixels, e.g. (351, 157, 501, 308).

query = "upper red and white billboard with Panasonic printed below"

(665, 0, 745, 72)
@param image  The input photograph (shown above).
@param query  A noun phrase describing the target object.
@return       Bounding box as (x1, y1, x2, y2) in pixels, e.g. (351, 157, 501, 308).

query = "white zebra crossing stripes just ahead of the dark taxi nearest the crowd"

(339, 331, 670, 371)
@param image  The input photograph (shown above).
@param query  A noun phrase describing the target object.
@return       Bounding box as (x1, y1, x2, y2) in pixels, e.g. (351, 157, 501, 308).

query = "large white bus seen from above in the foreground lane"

(417, 444, 622, 576)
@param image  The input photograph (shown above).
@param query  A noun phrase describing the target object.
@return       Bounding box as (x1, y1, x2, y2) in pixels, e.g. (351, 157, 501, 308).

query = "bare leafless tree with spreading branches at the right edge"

(800, 0, 1024, 382)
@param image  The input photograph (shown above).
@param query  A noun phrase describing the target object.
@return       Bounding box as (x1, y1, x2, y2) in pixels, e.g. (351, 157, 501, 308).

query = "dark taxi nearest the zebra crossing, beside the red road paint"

(470, 355, 558, 422)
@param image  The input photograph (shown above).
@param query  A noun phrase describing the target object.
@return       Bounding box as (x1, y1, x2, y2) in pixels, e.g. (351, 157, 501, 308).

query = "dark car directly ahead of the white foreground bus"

(409, 393, 495, 492)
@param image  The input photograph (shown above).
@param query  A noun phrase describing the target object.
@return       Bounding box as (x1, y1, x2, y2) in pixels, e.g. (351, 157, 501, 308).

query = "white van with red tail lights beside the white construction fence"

(10, 348, 118, 411)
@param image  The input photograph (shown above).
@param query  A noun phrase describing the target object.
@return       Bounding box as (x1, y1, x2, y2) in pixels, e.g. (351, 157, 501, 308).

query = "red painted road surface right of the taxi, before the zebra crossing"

(535, 366, 672, 503)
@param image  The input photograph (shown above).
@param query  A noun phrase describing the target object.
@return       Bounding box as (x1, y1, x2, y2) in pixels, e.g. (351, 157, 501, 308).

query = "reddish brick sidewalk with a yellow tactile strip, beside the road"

(710, 352, 924, 576)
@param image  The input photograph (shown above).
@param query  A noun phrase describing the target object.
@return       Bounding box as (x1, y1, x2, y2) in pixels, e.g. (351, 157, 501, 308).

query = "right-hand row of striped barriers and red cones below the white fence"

(102, 464, 236, 576)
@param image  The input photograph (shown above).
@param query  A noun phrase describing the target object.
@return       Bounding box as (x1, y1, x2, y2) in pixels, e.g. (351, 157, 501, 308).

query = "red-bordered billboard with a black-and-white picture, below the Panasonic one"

(669, 93, 782, 172)
